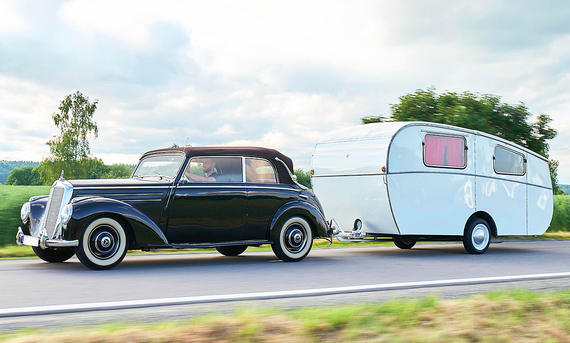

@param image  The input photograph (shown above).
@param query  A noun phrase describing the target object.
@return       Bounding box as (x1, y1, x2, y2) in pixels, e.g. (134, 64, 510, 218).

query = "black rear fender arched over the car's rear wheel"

(269, 201, 329, 238)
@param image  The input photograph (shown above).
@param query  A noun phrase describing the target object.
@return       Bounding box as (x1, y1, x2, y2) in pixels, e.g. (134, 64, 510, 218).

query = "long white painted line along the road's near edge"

(0, 272, 570, 317)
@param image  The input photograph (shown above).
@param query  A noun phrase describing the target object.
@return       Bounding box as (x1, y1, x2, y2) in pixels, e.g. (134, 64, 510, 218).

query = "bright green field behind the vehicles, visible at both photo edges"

(0, 185, 570, 247)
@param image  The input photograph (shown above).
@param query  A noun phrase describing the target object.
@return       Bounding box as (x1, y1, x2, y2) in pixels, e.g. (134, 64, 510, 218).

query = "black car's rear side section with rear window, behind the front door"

(244, 157, 299, 240)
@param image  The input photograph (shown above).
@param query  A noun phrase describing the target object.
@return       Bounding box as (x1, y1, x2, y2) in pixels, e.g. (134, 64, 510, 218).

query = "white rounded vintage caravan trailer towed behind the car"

(311, 122, 553, 254)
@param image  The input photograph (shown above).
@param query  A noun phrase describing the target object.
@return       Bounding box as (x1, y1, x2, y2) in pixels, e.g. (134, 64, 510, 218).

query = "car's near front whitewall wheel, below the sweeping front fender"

(76, 217, 127, 269)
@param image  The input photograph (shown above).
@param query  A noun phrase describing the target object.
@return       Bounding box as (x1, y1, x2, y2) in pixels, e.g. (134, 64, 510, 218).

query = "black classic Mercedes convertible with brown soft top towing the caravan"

(16, 147, 331, 269)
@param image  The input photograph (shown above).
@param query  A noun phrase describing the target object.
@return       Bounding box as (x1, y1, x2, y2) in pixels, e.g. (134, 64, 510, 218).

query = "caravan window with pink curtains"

(424, 134, 467, 168)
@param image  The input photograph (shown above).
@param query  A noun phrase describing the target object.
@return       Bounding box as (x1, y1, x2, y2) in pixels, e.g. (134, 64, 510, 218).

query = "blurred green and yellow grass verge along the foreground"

(0, 290, 570, 343)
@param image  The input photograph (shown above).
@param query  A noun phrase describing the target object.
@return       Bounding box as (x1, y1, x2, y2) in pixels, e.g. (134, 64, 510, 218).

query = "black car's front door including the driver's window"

(166, 156, 246, 243)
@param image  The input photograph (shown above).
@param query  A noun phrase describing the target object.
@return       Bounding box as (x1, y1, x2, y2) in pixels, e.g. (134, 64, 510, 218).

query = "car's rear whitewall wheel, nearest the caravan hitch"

(271, 217, 313, 262)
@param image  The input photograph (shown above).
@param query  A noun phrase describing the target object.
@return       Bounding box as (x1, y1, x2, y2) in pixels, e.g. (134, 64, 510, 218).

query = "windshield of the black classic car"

(133, 154, 185, 181)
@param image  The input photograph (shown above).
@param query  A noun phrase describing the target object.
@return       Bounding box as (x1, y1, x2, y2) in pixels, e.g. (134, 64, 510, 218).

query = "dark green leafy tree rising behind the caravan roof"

(362, 88, 558, 193)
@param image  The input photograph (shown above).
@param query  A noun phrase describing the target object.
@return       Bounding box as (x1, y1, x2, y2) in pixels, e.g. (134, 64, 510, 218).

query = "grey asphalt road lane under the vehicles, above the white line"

(0, 241, 570, 310)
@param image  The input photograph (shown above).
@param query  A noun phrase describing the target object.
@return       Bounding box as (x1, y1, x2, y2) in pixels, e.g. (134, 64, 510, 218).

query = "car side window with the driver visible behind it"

(181, 157, 243, 183)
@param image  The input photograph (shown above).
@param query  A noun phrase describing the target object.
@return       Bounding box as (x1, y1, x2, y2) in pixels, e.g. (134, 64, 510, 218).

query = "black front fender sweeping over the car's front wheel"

(64, 197, 168, 248)
